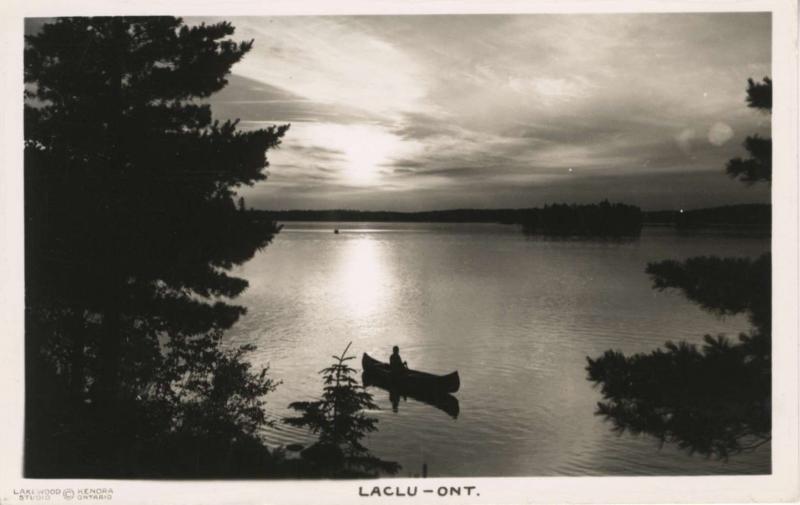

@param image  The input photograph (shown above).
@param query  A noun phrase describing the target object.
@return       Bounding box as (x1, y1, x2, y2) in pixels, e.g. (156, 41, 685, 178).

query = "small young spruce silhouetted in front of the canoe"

(284, 344, 400, 478)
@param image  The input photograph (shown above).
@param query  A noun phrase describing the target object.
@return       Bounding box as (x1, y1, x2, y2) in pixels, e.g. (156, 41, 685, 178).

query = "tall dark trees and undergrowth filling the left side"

(24, 17, 294, 477)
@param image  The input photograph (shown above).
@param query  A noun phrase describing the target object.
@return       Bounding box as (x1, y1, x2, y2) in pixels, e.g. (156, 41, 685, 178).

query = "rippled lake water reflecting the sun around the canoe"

(227, 223, 770, 477)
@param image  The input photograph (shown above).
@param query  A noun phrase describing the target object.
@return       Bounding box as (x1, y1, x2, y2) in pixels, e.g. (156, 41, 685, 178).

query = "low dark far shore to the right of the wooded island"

(644, 203, 772, 229)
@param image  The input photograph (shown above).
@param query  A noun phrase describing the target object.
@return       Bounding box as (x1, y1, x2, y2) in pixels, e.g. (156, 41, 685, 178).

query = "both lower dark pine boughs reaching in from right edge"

(586, 255, 772, 458)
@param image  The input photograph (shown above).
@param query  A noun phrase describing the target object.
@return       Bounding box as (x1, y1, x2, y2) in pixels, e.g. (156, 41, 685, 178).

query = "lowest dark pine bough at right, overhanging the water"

(587, 335, 771, 458)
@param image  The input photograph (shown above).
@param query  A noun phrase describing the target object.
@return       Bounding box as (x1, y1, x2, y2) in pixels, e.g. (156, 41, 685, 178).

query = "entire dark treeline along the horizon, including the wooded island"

(260, 201, 772, 234)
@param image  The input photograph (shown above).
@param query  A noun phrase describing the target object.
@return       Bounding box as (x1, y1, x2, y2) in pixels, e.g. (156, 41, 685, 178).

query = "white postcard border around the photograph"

(0, 0, 800, 505)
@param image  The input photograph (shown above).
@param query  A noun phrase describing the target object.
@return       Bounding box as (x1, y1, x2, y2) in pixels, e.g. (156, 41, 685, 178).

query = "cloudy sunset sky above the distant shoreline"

(112, 13, 771, 211)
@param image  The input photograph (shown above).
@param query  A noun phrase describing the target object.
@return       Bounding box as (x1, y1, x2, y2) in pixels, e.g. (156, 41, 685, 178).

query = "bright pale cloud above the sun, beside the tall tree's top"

(192, 17, 432, 119)
